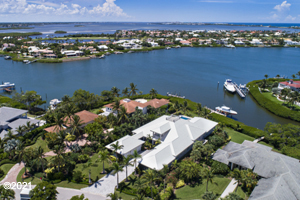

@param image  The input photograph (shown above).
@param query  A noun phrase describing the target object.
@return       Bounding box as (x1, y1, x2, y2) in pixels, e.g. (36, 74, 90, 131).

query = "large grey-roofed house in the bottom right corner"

(213, 140, 300, 200)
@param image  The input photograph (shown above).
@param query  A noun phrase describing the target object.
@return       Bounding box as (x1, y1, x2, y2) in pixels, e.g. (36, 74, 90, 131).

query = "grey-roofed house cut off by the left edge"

(0, 107, 40, 139)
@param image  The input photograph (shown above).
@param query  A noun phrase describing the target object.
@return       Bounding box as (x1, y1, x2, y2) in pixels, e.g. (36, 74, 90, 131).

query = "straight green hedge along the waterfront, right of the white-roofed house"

(211, 113, 266, 138)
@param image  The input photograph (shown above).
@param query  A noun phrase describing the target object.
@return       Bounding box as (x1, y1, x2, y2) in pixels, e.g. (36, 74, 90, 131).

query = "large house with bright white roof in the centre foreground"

(106, 115, 218, 170)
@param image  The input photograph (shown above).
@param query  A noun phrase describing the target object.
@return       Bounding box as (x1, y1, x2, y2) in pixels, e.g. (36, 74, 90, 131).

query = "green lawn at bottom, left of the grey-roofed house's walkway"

(175, 177, 230, 199)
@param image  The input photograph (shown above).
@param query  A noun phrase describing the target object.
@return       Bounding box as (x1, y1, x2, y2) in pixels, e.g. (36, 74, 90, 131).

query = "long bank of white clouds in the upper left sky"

(0, 0, 128, 17)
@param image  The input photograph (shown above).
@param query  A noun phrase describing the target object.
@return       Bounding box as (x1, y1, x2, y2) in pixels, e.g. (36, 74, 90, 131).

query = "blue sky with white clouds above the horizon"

(0, 0, 300, 23)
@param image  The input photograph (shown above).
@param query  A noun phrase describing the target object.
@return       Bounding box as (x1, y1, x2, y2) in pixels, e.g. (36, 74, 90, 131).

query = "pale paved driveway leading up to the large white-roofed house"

(81, 159, 141, 197)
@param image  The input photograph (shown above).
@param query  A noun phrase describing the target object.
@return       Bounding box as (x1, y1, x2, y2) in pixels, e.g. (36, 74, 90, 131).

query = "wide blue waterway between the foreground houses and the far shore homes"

(0, 48, 300, 129)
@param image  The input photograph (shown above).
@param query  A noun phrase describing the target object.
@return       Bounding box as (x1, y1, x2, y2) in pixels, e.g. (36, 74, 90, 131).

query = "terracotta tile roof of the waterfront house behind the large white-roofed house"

(105, 99, 169, 114)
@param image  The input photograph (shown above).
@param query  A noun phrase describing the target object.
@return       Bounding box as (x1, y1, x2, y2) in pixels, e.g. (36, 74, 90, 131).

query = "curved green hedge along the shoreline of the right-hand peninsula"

(247, 79, 300, 122)
